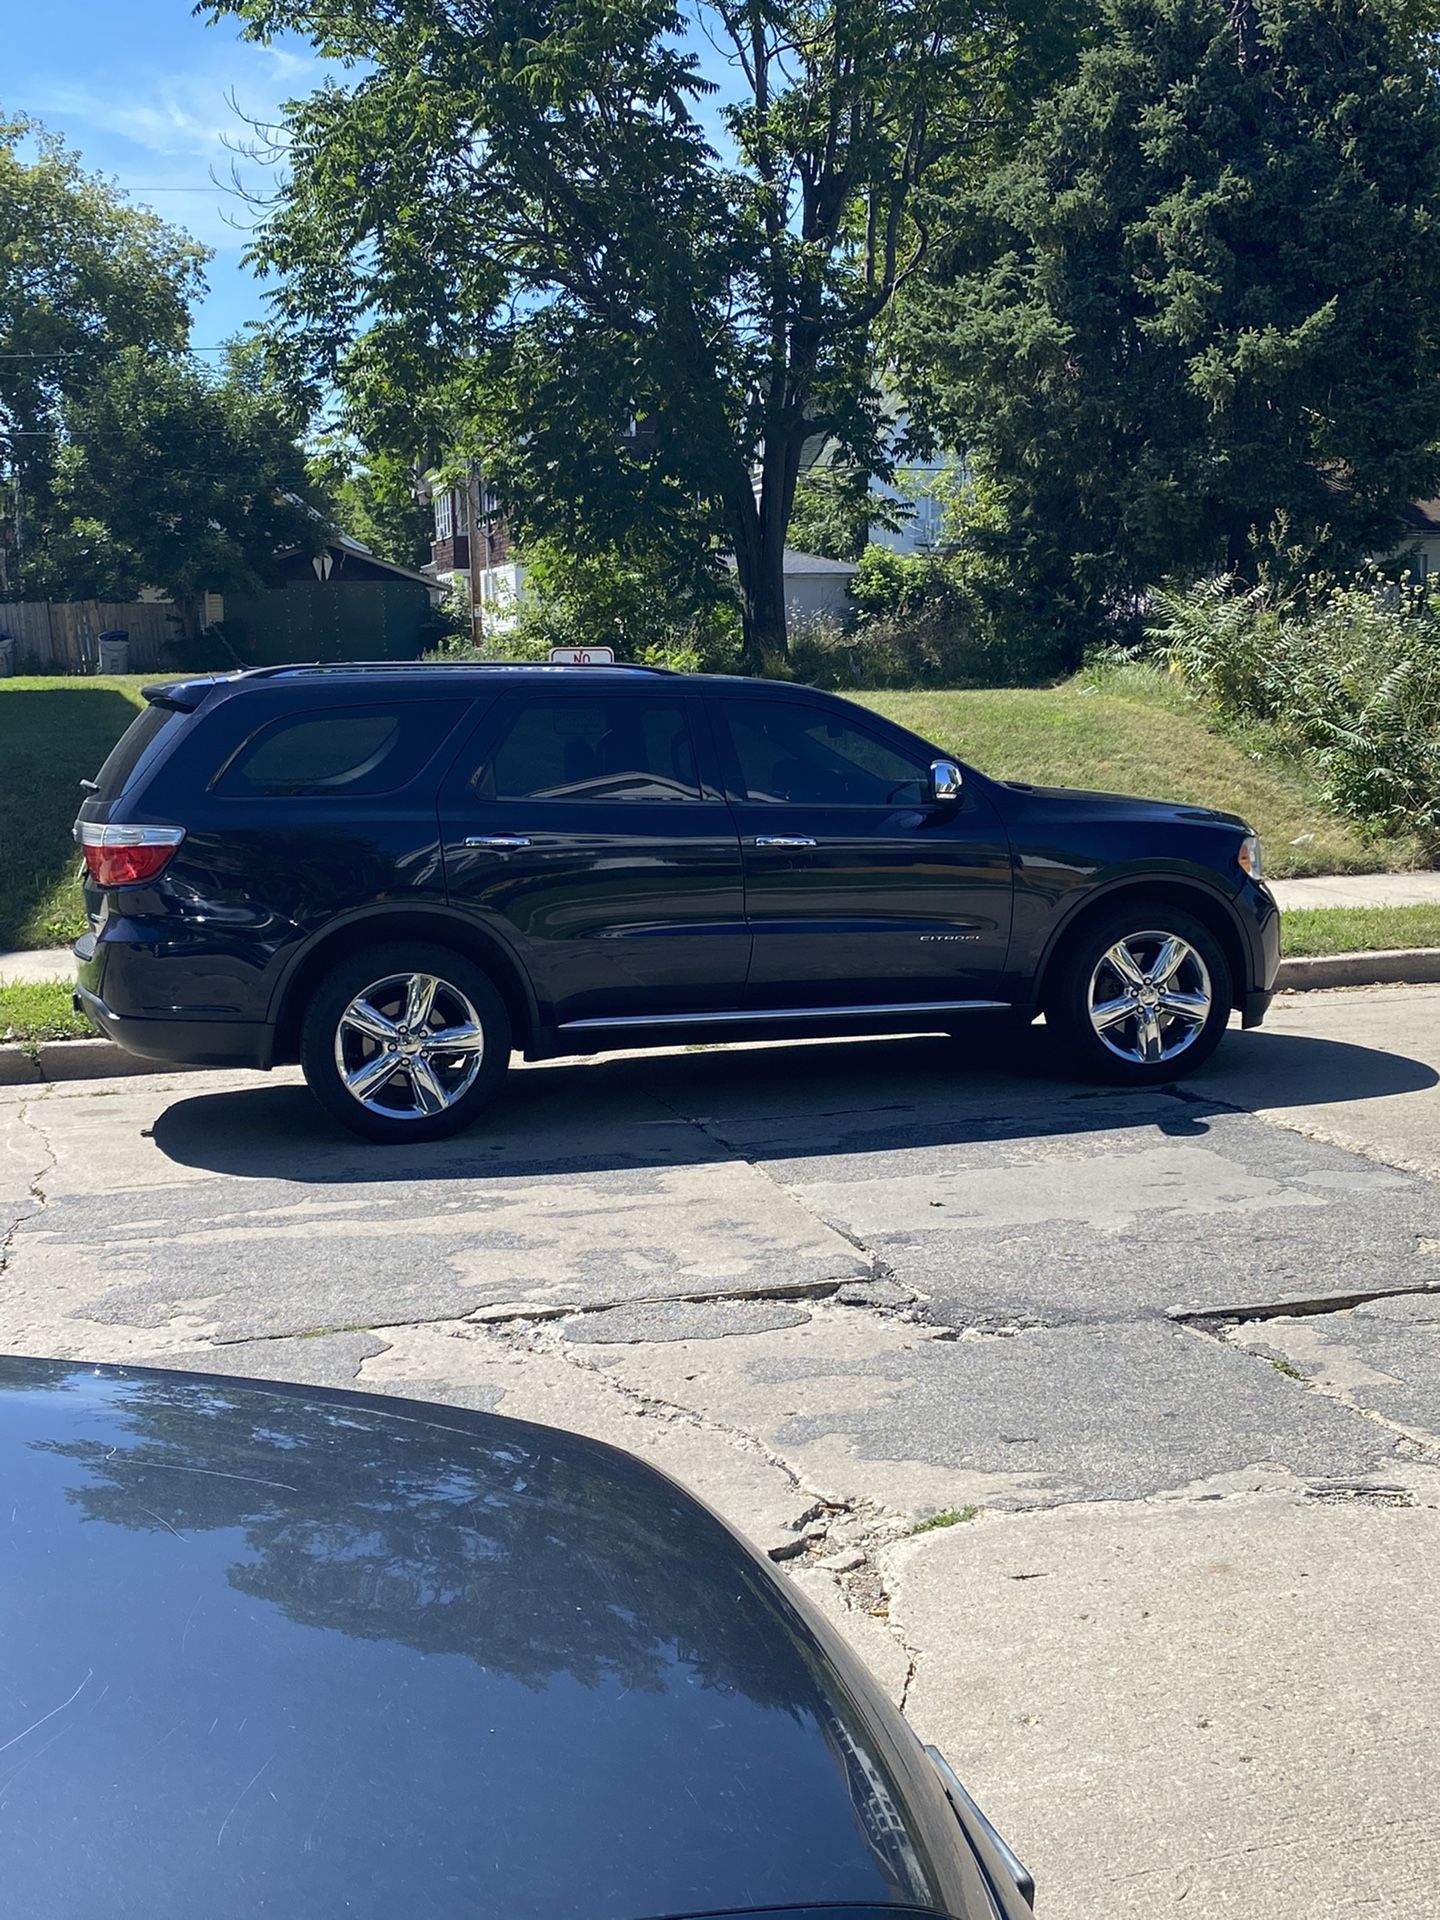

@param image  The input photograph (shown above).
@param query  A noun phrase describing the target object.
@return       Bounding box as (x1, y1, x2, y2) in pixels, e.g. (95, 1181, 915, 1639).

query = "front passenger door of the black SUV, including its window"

(714, 693, 1012, 1008)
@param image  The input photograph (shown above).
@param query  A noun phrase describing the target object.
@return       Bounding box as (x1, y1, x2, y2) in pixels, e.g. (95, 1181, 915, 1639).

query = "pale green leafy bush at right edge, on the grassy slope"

(1150, 570, 1440, 847)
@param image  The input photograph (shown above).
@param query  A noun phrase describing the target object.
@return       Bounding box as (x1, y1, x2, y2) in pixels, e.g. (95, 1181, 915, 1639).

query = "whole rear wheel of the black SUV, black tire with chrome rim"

(300, 941, 511, 1144)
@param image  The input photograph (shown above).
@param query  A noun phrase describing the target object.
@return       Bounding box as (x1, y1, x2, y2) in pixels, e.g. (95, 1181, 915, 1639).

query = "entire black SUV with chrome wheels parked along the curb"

(75, 666, 1279, 1140)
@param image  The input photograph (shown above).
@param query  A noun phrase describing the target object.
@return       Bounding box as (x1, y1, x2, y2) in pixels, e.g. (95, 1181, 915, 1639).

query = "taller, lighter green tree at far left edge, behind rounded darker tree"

(0, 115, 209, 595)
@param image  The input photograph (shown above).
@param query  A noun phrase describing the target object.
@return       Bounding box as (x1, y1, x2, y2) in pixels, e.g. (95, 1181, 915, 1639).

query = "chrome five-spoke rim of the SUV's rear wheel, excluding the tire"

(334, 973, 486, 1119)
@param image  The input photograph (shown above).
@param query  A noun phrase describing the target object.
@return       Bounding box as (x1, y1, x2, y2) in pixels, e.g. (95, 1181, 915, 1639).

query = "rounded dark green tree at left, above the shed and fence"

(33, 344, 328, 605)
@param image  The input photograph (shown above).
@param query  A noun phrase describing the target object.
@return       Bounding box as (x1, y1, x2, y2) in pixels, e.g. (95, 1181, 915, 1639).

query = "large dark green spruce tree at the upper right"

(904, 0, 1440, 660)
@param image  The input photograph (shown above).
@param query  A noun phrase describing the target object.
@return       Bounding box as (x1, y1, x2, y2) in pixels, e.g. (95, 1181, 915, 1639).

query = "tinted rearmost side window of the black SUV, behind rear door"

(217, 701, 461, 799)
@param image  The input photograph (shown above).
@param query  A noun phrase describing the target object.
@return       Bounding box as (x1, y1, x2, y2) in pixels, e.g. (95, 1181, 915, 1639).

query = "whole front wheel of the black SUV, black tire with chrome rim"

(1044, 899, 1231, 1087)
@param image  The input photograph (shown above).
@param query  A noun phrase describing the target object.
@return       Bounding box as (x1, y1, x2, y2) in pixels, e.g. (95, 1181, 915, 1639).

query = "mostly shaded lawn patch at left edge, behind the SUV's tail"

(0, 674, 156, 950)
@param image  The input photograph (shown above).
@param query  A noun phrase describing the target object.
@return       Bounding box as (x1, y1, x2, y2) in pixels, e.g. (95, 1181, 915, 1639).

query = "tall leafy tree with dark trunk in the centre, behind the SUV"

(213, 0, 1075, 664)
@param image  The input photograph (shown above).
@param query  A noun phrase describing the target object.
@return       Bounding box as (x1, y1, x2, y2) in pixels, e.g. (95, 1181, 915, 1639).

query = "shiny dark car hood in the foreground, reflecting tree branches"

(0, 1359, 989, 1920)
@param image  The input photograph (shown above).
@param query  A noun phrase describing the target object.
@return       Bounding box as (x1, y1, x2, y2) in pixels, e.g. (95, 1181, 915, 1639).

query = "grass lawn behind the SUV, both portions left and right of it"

(0, 674, 1423, 950)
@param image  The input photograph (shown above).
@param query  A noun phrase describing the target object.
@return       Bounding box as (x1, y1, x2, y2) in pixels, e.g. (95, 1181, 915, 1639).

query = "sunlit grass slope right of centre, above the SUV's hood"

(852, 674, 1423, 879)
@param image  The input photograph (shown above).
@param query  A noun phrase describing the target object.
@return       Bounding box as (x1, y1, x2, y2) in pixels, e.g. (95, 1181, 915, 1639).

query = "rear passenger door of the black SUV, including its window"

(440, 676, 751, 1025)
